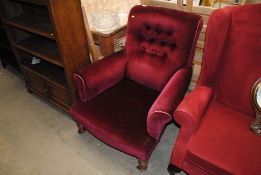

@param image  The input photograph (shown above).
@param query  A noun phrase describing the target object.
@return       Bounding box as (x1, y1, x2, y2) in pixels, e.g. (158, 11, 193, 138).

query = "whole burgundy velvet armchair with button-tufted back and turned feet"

(70, 6, 202, 170)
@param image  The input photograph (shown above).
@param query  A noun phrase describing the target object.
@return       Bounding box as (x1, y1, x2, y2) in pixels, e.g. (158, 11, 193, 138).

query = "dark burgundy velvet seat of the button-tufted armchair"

(71, 79, 159, 160)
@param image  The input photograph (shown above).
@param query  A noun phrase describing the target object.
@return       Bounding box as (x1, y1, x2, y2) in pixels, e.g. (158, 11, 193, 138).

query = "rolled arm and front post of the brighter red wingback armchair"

(171, 86, 213, 167)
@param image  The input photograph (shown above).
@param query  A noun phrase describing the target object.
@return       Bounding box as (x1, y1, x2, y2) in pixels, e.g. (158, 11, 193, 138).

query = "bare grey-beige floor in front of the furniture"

(0, 66, 184, 175)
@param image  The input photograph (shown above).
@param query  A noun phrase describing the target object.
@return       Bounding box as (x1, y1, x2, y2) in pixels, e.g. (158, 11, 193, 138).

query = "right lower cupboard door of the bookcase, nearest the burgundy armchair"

(48, 82, 71, 107)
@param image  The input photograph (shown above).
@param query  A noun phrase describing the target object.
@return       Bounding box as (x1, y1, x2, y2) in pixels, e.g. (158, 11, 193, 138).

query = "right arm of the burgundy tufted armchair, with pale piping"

(147, 67, 192, 139)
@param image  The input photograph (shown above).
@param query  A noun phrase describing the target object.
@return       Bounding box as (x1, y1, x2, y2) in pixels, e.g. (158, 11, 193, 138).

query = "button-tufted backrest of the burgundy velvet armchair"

(126, 6, 202, 91)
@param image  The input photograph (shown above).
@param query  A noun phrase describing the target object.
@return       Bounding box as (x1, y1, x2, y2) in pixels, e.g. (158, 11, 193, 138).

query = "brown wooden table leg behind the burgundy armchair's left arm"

(99, 36, 114, 56)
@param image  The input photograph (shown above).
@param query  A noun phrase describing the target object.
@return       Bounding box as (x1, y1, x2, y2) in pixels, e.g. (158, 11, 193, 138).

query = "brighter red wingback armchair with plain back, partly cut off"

(169, 4, 261, 175)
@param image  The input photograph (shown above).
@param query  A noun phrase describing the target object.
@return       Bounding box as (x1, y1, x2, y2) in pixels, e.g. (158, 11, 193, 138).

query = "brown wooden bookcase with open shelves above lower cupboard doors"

(1, 0, 90, 111)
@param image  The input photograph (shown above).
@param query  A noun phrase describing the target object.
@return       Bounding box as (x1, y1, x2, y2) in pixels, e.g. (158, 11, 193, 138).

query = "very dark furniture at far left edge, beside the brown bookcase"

(0, 10, 20, 71)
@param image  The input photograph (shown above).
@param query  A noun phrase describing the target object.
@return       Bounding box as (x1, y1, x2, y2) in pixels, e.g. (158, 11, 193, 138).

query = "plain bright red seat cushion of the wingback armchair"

(186, 102, 261, 175)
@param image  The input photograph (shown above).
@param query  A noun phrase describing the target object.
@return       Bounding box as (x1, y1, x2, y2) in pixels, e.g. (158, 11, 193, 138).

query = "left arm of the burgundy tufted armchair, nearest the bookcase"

(73, 50, 126, 102)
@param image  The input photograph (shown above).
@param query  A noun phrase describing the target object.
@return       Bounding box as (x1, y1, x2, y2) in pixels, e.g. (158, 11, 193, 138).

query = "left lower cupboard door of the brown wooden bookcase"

(23, 69, 48, 96)
